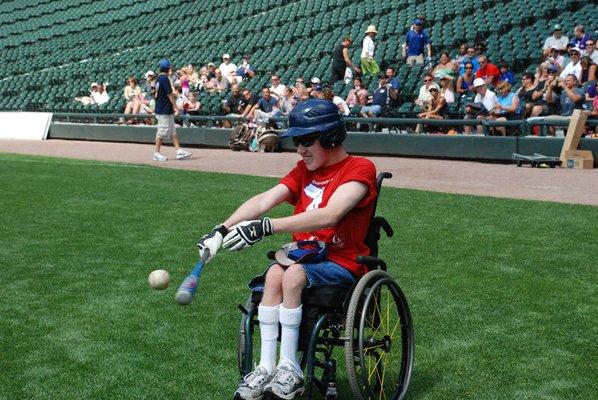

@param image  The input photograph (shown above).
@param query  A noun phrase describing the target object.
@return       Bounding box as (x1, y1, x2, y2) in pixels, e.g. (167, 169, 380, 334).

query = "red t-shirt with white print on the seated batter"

(280, 156, 377, 276)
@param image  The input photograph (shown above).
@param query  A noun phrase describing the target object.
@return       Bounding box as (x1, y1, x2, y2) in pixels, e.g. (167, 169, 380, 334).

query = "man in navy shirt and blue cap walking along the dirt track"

(153, 59, 191, 161)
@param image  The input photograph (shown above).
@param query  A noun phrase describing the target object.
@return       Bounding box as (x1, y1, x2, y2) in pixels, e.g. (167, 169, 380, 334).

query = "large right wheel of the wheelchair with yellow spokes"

(345, 270, 415, 400)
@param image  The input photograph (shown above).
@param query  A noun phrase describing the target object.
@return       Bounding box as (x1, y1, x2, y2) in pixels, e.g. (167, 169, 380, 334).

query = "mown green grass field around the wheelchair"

(0, 154, 598, 400)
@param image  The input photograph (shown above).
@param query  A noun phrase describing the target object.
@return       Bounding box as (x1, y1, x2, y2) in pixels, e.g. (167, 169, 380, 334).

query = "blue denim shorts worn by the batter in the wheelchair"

(249, 260, 355, 292)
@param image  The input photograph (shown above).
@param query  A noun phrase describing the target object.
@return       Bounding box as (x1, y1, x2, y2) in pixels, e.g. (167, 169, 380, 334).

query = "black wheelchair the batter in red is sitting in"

(237, 172, 415, 400)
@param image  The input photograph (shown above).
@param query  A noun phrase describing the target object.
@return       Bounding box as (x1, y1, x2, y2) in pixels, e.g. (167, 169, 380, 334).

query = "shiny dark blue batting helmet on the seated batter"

(281, 99, 347, 149)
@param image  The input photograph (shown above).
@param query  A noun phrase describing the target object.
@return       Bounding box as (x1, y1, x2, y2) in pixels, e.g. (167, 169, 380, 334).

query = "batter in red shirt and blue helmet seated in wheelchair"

(197, 99, 377, 400)
